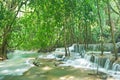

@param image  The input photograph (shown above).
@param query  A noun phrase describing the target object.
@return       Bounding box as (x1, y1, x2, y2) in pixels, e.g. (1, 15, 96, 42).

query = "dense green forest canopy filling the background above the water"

(0, 0, 120, 57)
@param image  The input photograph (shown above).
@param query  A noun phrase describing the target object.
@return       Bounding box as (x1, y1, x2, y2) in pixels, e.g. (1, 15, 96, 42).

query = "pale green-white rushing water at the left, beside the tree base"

(0, 50, 34, 80)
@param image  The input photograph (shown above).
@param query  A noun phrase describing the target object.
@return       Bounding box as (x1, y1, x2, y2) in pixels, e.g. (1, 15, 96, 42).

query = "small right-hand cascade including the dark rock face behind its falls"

(56, 45, 120, 80)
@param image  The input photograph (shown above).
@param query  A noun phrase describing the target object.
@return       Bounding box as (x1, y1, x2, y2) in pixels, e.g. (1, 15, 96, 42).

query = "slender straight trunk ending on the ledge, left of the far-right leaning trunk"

(97, 0, 104, 55)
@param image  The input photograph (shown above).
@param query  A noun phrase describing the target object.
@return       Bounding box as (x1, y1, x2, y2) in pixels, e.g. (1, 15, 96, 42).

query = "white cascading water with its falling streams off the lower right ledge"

(59, 49, 120, 80)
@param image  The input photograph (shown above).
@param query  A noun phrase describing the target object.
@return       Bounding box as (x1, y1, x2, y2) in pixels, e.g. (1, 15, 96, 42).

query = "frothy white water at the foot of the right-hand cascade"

(59, 55, 120, 80)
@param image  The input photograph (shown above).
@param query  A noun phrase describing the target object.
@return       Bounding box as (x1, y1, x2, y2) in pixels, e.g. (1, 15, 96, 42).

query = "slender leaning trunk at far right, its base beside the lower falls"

(107, 0, 118, 60)
